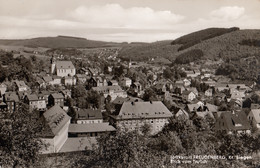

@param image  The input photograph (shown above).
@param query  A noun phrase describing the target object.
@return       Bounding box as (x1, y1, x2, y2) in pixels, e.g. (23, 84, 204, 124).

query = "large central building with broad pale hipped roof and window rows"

(111, 101, 173, 134)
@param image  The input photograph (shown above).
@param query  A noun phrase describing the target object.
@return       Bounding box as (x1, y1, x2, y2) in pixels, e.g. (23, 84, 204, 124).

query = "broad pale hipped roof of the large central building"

(115, 101, 172, 119)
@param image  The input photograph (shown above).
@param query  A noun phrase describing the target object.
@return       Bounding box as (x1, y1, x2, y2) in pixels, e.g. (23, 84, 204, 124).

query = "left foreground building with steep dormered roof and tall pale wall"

(40, 105, 71, 153)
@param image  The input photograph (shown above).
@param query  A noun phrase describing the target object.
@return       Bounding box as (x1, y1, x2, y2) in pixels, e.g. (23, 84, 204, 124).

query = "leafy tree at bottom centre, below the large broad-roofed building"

(84, 130, 164, 168)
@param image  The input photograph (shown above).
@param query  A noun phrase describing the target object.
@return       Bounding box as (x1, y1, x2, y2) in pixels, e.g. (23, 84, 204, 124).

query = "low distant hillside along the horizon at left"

(0, 36, 120, 48)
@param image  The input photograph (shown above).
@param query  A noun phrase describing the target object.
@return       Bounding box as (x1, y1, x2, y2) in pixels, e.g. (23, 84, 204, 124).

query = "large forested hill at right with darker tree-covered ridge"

(119, 28, 260, 63)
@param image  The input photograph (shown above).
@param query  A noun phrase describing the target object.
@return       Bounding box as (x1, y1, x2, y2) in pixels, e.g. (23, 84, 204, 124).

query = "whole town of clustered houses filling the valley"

(0, 35, 260, 167)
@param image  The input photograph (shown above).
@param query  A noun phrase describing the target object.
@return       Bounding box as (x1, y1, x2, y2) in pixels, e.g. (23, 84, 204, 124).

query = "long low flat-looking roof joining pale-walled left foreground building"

(69, 122, 116, 133)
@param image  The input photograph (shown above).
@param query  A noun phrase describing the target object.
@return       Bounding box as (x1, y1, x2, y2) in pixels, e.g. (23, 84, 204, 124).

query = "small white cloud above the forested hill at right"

(210, 6, 245, 21)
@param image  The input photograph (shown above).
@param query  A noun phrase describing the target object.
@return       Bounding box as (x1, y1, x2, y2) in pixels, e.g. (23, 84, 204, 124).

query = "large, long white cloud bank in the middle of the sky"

(70, 4, 184, 29)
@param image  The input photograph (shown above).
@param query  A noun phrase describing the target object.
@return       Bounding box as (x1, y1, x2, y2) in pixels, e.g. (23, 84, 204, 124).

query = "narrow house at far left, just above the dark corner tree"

(4, 92, 19, 112)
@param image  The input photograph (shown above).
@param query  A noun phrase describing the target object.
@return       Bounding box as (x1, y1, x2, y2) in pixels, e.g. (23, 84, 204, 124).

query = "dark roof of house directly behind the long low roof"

(76, 109, 103, 120)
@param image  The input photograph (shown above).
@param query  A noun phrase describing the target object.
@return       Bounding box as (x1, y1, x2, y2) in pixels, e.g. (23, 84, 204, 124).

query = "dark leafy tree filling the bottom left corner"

(0, 104, 44, 167)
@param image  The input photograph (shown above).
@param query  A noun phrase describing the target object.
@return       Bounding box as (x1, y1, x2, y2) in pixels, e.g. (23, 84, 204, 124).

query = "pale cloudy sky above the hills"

(0, 0, 260, 42)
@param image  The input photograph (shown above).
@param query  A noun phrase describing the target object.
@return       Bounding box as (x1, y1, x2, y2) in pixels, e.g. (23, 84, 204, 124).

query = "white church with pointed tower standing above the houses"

(51, 60, 76, 77)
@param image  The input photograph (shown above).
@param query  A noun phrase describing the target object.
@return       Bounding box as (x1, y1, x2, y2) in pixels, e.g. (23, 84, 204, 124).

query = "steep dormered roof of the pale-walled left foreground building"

(43, 105, 71, 136)
